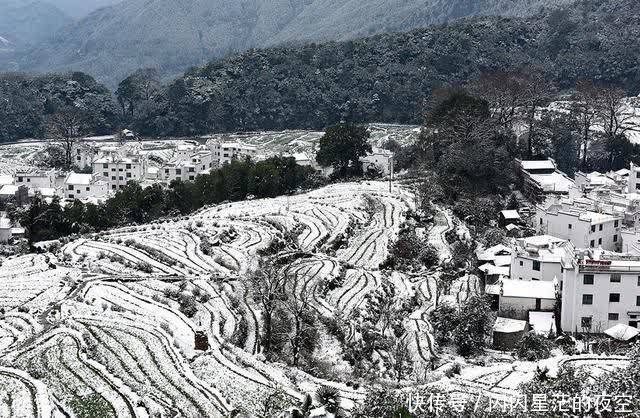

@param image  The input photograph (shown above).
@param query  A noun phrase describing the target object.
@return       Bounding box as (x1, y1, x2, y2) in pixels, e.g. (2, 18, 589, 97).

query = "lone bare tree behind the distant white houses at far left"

(47, 107, 87, 168)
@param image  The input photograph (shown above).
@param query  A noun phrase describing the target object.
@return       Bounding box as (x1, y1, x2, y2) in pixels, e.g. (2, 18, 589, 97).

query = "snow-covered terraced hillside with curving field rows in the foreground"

(0, 182, 618, 417)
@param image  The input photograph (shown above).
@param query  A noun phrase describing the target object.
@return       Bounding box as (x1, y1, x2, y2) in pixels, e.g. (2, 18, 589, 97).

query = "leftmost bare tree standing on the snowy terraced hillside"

(251, 260, 285, 352)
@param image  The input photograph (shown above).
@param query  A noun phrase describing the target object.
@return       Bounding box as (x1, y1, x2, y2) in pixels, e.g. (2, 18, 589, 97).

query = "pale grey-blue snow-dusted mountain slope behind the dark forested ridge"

(5, 0, 572, 87)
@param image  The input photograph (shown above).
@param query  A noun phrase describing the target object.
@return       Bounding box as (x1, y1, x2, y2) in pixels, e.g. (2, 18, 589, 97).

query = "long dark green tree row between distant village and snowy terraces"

(7, 157, 322, 243)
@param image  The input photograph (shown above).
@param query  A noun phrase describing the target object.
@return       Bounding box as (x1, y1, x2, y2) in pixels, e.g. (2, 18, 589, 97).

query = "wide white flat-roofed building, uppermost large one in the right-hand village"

(534, 203, 624, 251)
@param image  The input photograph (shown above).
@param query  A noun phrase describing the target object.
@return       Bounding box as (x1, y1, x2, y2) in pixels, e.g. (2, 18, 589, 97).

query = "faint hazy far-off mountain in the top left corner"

(0, 0, 72, 48)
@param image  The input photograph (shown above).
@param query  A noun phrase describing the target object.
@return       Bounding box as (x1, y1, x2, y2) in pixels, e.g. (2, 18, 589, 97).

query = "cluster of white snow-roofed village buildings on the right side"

(478, 160, 640, 349)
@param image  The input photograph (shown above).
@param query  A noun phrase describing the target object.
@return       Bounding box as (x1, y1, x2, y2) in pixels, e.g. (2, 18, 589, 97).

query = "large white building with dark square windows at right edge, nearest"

(561, 250, 640, 333)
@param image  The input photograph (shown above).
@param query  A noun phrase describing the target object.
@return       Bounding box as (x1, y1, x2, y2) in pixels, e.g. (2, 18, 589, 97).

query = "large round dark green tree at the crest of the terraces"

(316, 123, 371, 177)
